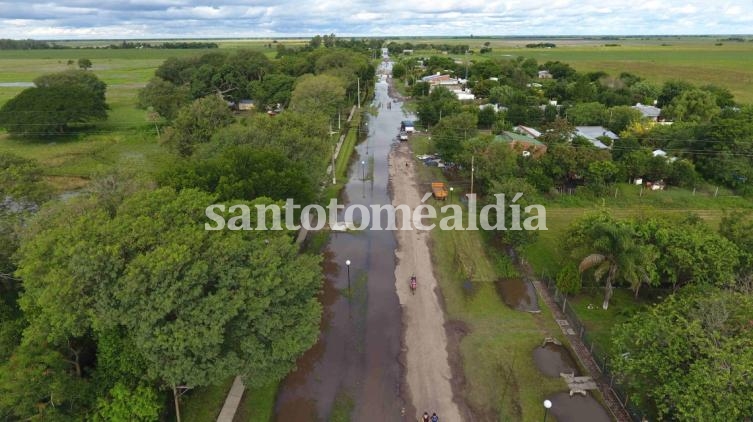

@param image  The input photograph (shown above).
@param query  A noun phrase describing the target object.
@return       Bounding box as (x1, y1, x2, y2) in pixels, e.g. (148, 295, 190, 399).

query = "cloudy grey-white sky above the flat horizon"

(0, 0, 753, 39)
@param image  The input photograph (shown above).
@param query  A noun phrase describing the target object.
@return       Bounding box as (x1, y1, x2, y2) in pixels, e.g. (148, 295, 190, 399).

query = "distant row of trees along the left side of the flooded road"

(139, 48, 376, 119)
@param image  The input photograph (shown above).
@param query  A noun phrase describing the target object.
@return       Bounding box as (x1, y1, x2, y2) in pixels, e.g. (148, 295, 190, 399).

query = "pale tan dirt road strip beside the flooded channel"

(390, 143, 463, 422)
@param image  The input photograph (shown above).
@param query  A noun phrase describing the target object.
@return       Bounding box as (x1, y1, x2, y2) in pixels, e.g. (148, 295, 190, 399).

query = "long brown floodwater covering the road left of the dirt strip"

(276, 64, 409, 422)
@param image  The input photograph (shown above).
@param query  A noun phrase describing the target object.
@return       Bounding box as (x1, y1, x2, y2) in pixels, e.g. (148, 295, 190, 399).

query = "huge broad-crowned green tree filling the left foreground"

(13, 189, 321, 420)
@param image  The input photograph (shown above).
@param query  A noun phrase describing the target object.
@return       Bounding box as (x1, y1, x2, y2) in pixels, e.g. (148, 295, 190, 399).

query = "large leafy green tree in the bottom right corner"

(611, 289, 753, 421)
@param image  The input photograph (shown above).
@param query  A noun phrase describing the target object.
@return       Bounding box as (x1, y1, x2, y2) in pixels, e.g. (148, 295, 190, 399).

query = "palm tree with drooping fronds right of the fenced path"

(578, 221, 653, 310)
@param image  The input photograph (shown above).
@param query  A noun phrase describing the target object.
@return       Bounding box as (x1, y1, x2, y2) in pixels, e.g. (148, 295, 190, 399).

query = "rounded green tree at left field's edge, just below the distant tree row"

(163, 95, 234, 157)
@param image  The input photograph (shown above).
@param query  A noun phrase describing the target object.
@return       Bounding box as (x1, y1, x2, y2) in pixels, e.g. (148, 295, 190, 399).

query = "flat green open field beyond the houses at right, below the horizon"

(390, 36, 753, 103)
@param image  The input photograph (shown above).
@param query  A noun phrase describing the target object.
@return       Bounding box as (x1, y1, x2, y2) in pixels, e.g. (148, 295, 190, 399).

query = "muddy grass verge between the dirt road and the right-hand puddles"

(432, 216, 565, 421)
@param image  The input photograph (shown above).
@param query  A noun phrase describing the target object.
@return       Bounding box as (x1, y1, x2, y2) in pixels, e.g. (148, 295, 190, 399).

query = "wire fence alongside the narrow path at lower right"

(540, 275, 648, 422)
